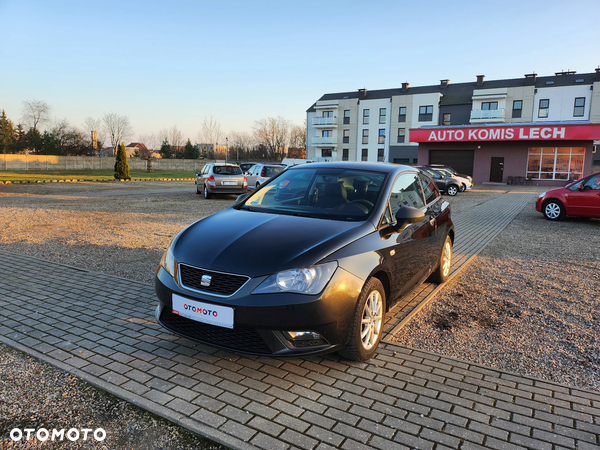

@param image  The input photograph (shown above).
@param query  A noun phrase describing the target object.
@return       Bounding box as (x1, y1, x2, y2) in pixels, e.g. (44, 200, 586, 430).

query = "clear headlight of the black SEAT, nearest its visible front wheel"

(252, 261, 338, 295)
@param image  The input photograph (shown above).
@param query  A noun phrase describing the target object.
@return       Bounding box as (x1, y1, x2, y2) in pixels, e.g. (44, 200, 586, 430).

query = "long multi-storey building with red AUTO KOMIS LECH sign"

(307, 69, 600, 185)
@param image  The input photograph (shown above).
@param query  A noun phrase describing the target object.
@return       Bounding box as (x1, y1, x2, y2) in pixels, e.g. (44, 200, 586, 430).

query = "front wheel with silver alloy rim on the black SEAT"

(339, 278, 386, 361)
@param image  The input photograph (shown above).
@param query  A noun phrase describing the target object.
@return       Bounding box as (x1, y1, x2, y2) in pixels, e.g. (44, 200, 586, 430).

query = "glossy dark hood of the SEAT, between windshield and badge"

(173, 208, 375, 277)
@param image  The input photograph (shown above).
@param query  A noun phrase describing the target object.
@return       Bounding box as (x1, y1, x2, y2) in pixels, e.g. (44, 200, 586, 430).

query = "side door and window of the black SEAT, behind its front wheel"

(386, 173, 436, 297)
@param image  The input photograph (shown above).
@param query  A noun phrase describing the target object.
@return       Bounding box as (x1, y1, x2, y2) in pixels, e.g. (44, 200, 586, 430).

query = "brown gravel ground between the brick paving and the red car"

(394, 188, 600, 391)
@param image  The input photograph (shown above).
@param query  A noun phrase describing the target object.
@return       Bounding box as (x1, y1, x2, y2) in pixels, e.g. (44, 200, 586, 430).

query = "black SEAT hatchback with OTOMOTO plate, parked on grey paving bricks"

(155, 162, 454, 361)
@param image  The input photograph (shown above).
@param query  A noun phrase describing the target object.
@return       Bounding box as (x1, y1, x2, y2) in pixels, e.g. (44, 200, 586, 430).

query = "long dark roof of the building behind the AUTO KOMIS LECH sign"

(306, 72, 598, 112)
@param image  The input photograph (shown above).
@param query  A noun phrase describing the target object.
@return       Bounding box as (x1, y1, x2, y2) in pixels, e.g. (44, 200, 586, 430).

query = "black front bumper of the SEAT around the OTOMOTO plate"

(155, 267, 363, 356)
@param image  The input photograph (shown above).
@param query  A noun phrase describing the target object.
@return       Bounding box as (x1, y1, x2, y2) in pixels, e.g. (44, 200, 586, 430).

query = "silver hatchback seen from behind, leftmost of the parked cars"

(195, 163, 248, 199)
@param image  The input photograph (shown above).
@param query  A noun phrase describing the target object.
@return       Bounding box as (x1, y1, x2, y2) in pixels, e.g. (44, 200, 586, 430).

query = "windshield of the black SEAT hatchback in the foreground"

(242, 168, 387, 221)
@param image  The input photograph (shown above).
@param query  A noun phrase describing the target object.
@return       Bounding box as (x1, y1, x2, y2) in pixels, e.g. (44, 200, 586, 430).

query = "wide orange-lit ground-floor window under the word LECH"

(527, 147, 585, 180)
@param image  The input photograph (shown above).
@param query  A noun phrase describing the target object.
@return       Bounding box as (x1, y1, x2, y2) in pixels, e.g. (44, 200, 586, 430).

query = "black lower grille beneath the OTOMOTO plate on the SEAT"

(160, 308, 273, 355)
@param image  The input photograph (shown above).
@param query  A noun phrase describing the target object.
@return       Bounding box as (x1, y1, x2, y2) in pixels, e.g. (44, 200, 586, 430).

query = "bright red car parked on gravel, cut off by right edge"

(535, 172, 600, 220)
